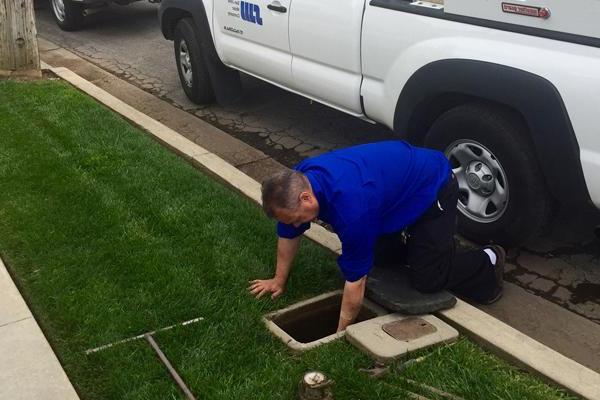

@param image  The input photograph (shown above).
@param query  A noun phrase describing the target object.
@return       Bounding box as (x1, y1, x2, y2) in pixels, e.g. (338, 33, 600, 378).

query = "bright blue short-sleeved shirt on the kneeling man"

(277, 141, 450, 282)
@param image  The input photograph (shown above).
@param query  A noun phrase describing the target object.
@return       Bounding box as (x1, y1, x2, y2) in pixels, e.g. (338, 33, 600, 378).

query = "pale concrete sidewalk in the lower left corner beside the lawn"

(0, 260, 79, 400)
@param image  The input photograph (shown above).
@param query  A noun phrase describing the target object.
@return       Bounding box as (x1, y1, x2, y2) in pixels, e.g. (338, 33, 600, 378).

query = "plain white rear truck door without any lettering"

(290, 0, 365, 115)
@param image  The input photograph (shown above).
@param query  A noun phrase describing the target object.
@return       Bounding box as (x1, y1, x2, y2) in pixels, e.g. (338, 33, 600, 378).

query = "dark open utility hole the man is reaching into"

(270, 293, 380, 343)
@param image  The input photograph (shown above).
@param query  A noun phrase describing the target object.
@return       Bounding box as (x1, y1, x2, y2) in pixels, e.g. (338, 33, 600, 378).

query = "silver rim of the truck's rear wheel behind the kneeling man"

(445, 139, 509, 223)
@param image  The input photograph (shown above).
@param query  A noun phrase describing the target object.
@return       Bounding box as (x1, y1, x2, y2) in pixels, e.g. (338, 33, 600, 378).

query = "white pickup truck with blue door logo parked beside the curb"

(159, 0, 600, 244)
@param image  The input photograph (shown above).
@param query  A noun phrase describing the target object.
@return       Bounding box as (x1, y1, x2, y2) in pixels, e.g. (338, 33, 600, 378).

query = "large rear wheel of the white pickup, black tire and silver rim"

(425, 103, 552, 246)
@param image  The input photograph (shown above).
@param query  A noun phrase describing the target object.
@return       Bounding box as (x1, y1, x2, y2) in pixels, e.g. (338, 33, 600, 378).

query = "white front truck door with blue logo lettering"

(213, 0, 292, 86)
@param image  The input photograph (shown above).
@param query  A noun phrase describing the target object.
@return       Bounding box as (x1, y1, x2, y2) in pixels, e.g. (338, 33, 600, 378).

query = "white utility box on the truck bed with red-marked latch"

(444, 0, 600, 38)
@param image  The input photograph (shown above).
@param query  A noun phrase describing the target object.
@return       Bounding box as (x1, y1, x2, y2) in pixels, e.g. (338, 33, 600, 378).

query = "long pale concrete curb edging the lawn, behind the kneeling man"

(44, 68, 600, 400)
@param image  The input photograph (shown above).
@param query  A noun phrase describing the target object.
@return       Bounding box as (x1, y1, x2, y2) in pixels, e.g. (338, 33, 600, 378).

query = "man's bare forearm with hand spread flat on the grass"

(248, 236, 302, 299)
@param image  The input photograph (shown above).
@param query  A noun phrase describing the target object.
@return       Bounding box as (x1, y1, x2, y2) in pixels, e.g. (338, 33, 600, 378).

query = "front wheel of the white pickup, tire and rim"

(174, 18, 215, 104)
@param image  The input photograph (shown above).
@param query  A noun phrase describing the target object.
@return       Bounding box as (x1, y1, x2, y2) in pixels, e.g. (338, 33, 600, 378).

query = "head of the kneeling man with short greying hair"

(262, 169, 319, 227)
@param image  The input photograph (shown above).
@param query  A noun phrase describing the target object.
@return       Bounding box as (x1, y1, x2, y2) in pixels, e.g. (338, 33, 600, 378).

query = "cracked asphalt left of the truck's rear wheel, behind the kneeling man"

(36, 0, 393, 164)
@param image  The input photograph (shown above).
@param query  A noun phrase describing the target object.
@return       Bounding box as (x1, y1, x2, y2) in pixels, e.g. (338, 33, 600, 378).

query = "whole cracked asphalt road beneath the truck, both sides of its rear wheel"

(36, 0, 600, 323)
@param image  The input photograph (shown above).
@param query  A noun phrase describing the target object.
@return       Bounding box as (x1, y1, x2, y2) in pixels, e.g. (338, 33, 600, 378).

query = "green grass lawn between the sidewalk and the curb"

(0, 81, 572, 400)
